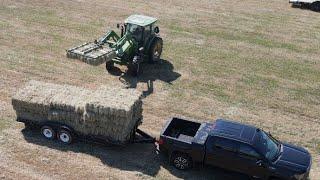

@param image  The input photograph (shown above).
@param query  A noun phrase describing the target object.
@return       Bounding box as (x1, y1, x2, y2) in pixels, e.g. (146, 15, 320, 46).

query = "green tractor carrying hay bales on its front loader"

(67, 15, 163, 76)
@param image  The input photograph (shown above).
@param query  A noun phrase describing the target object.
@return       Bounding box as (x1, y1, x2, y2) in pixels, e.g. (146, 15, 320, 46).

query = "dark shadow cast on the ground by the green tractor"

(113, 59, 181, 97)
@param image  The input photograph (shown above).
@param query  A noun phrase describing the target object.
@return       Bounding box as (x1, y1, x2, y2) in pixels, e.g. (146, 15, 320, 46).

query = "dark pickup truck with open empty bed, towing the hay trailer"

(158, 118, 311, 179)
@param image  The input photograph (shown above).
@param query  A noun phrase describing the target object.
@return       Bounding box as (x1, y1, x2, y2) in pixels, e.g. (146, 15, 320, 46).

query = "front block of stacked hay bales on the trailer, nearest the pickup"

(85, 86, 142, 141)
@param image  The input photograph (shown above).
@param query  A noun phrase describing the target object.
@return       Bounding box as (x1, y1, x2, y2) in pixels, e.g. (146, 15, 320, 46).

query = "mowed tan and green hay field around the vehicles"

(0, 0, 320, 179)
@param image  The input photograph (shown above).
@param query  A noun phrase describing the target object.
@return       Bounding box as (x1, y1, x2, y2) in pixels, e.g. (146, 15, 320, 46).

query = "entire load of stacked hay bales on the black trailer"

(12, 81, 142, 143)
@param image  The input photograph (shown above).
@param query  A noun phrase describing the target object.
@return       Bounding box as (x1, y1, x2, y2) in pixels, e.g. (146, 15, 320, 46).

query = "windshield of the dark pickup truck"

(257, 131, 280, 161)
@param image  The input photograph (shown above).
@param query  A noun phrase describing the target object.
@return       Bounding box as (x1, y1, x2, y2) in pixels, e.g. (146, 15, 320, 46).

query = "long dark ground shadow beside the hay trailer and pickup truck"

(21, 128, 246, 180)
